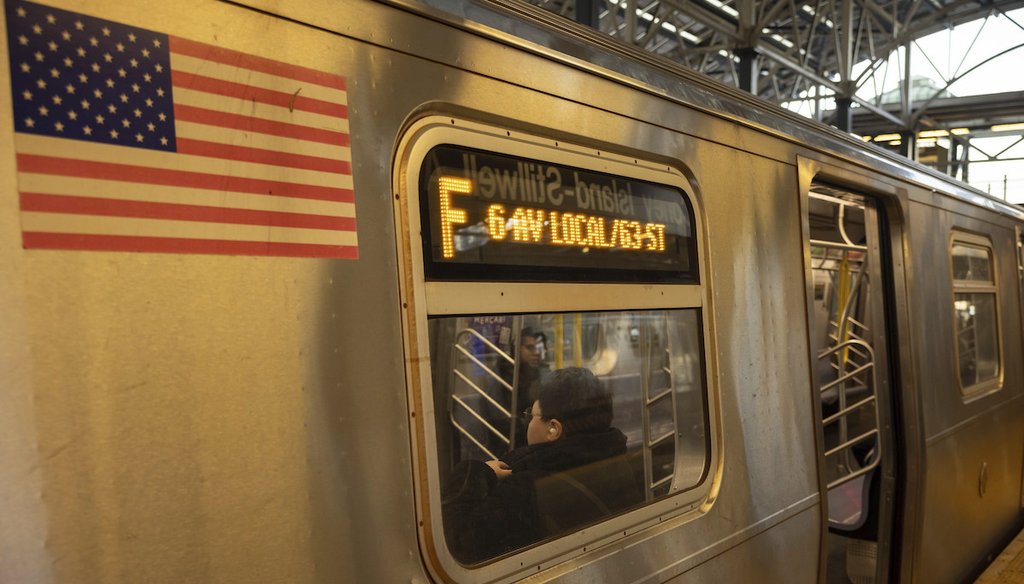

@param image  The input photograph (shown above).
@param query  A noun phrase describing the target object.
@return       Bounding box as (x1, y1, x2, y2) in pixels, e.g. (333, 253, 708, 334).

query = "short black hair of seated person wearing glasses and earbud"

(538, 367, 613, 435)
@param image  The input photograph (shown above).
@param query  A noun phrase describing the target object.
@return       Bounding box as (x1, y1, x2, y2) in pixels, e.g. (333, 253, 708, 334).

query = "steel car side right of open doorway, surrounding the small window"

(910, 196, 1024, 581)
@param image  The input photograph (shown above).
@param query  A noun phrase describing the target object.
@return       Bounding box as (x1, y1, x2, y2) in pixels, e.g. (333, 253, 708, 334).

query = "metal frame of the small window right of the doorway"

(947, 230, 1006, 403)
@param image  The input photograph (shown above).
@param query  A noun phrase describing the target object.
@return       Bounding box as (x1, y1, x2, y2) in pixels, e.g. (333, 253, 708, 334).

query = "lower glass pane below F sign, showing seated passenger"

(429, 308, 709, 564)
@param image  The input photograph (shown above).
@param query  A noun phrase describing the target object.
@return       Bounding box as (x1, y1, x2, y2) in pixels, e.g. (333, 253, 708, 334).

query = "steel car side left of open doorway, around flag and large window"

(0, 1, 932, 582)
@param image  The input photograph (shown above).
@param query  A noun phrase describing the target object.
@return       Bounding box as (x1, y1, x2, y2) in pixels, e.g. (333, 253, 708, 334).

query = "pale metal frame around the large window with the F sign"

(393, 115, 722, 582)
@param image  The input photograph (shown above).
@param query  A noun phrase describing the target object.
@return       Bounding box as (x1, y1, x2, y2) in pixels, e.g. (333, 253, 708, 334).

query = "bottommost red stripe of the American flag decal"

(22, 232, 359, 259)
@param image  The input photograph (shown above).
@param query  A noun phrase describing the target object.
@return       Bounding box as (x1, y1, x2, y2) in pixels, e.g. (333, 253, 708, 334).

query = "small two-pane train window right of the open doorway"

(950, 233, 1001, 397)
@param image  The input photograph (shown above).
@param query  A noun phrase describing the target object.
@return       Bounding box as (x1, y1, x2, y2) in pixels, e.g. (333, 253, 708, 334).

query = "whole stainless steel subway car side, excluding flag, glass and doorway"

(0, 0, 1024, 583)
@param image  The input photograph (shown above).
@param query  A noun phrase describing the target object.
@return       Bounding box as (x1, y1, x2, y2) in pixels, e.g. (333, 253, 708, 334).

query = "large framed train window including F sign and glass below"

(395, 116, 722, 582)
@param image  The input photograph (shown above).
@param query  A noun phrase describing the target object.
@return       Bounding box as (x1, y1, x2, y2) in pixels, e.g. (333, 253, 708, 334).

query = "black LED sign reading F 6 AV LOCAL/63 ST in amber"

(420, 145, 696, 282)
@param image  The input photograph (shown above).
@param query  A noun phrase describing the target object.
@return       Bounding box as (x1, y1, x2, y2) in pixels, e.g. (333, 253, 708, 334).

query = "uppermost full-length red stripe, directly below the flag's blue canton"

(17, 154, 355, 203)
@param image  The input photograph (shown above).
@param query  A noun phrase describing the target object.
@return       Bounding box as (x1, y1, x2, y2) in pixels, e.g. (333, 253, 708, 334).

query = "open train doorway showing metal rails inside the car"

(807, 182, 896, 584)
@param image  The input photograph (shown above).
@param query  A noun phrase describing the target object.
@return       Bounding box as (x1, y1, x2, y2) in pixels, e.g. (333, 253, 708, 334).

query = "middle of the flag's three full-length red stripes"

(22, 193, 355, 232)
